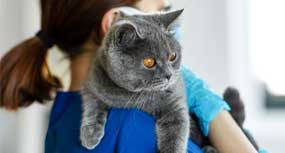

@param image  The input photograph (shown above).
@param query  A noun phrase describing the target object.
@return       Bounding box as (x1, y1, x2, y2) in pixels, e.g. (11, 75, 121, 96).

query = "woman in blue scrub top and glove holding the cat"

(0, 0, 256, 153)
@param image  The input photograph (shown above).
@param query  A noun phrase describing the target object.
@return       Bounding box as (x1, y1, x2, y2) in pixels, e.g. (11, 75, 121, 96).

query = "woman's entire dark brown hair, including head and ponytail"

(0, 0, 139, 110)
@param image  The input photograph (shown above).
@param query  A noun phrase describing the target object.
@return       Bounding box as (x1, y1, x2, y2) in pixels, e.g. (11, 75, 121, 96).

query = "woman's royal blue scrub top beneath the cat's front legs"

(45, 92, 203, 153)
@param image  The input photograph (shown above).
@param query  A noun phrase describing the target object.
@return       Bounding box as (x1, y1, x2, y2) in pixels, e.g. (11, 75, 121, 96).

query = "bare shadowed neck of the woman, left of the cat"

(69, 41, 97, 91)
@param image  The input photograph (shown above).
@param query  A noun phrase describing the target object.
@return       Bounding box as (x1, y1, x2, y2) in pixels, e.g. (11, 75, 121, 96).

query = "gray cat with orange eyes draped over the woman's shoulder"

(80, 10, 190, 153)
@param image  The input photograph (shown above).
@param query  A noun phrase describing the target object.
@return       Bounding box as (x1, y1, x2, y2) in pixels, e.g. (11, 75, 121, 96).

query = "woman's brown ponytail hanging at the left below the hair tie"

(0, 37, 61, 110)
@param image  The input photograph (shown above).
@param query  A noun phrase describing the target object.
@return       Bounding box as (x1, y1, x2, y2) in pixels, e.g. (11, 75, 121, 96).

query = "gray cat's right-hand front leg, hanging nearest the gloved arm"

(156, 110, 190, 153)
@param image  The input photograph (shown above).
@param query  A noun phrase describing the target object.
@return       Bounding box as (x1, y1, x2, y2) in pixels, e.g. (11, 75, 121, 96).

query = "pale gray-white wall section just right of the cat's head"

(174, 0, 229, 93)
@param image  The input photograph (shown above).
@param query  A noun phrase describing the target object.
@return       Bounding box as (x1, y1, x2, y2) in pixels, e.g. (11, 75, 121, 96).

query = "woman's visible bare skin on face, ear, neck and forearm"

(69, 0, 257, 153)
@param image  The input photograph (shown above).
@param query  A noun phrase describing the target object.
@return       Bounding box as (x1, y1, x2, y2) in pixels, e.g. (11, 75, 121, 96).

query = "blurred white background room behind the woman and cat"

(0, 0, 285, 153)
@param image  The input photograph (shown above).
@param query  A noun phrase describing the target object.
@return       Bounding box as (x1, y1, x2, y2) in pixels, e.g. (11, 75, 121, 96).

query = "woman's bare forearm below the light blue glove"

(209, 111, 257, 153)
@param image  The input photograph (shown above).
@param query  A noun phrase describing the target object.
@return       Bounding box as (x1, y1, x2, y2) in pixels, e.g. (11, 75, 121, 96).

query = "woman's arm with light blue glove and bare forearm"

(181, 66, 257, 153)
